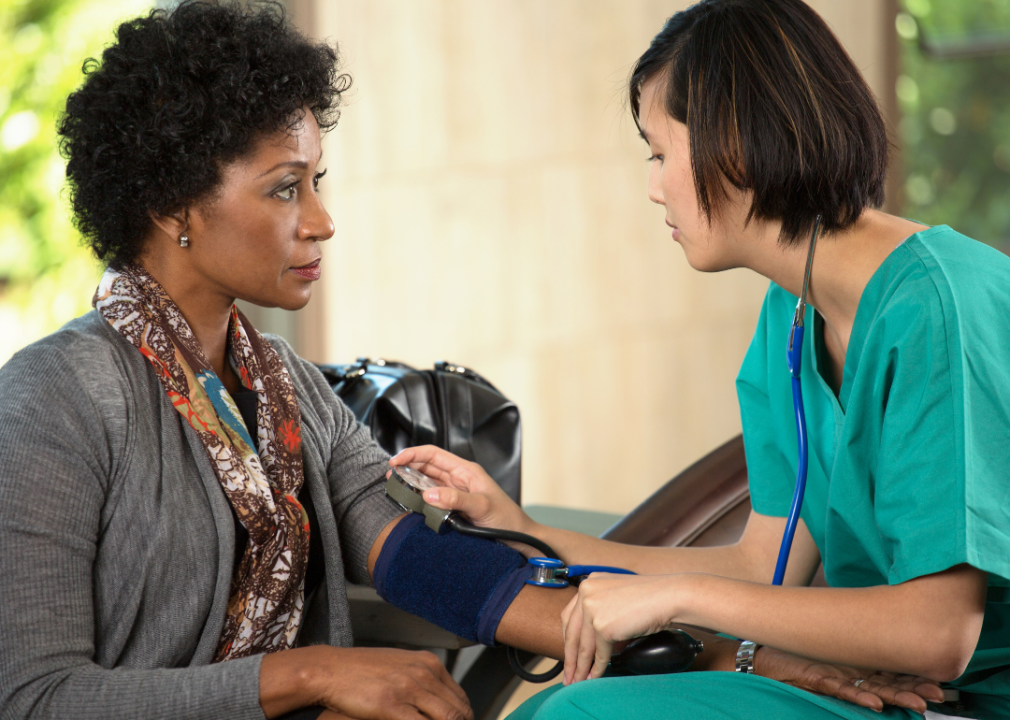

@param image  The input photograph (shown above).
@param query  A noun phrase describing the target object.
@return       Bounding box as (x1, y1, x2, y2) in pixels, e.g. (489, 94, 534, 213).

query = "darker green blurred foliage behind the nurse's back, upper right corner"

(896, 0, 1010, 251)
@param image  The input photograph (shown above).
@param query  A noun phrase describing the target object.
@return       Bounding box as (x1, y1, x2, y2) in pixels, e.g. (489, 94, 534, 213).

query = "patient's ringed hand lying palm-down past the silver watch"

(754, 647, 943, 713)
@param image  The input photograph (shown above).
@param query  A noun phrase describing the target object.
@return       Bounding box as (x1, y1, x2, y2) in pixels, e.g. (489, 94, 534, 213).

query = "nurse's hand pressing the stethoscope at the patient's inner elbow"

(562, 573, 678, 685)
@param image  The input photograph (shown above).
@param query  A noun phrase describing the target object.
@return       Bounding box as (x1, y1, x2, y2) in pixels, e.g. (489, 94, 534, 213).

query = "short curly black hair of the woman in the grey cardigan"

(59, 1, 350, 267)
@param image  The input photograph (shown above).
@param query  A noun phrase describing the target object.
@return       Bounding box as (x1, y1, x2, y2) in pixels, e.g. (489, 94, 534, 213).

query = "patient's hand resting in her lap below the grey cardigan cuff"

(260, 645, 474, 720)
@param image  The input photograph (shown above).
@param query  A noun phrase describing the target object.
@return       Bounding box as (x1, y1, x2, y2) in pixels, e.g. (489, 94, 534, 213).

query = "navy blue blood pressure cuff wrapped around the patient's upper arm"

(373, 513, 533, 645)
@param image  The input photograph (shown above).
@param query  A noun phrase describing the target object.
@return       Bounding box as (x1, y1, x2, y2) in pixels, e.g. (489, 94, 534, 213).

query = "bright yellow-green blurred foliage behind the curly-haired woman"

(0, 0, 152, 363)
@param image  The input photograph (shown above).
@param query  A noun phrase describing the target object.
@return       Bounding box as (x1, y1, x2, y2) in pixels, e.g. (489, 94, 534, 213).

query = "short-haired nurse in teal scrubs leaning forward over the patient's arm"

(394, 0, 1010, 720)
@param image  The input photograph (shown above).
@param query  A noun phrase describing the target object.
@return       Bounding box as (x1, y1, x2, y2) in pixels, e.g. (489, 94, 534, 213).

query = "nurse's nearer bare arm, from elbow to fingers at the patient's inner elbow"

(564, 565, 987, 682)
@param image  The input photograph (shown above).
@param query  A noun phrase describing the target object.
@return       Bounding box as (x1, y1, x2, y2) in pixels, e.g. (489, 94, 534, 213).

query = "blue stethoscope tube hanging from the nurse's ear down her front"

(772, 215, 821, 585)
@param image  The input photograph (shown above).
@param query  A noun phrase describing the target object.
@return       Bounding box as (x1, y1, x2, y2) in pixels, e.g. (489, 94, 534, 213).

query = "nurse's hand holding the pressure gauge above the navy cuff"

(389, 445, 536, 534)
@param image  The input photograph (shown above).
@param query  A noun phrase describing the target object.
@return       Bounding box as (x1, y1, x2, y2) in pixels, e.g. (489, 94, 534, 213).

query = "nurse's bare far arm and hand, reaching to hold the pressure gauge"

(390, 445, 820, 585)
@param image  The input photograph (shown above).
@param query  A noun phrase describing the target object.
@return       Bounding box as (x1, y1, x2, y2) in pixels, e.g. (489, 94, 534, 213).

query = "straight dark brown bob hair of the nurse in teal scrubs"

(629, 0, 888, 243)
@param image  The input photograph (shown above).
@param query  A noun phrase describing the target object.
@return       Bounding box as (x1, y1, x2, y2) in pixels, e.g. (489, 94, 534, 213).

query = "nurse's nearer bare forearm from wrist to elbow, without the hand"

(650, 564, 988, 682)
